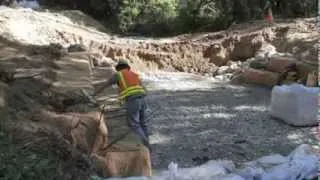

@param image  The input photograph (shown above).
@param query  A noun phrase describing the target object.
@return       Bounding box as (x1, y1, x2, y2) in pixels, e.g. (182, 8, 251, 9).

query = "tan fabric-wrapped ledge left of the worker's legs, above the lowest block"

(31, 111, 108, 154)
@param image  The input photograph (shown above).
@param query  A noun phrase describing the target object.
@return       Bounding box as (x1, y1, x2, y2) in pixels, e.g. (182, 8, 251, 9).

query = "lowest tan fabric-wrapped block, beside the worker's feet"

(92, 144, 152, 177)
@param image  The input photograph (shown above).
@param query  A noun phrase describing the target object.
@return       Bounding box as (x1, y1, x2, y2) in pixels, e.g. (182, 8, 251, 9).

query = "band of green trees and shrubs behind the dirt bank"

(40, 0, 317, 35)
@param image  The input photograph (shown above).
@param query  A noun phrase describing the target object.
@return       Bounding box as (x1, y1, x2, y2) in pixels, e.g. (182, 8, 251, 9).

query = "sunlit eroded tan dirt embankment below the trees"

(0, 9, 318, 75)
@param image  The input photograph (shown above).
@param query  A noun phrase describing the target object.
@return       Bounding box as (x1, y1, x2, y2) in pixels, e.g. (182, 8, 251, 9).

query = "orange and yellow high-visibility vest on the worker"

(117, 69, 146, 100)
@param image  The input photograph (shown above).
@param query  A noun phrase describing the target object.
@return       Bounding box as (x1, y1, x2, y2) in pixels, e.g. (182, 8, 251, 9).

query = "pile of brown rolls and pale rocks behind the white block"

(231, 44, 318, 87)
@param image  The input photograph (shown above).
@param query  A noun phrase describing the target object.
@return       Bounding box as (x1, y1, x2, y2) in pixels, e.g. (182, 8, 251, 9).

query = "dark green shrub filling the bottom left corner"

(0, 130, 94, 180)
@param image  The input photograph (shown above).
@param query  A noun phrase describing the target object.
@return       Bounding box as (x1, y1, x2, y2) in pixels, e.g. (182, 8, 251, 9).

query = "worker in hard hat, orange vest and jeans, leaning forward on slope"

(95, 60, 151, 150)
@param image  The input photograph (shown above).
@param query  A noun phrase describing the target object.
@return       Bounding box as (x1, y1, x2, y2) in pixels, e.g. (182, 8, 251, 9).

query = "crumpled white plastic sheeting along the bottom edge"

(103, 144, 320, 180)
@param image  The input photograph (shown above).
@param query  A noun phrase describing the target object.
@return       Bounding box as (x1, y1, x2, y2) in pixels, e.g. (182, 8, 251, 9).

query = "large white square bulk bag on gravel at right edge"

(270, 84, 320, 126)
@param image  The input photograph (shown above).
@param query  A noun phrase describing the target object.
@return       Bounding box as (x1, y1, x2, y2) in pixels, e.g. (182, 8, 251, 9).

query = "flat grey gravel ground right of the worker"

(145, 73, 317, 169)
